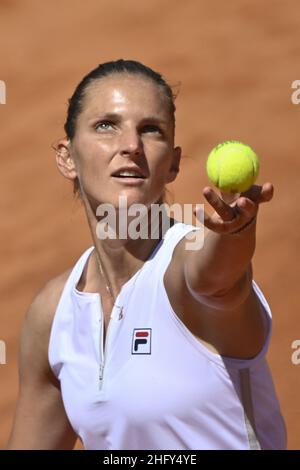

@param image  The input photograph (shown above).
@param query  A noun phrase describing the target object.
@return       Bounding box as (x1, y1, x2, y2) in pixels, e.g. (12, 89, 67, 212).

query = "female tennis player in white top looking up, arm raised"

(8, 60, 286, 450)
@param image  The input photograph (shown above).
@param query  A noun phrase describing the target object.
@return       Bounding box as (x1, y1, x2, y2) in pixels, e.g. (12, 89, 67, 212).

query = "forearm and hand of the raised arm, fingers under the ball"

(185, 183, 273, 308)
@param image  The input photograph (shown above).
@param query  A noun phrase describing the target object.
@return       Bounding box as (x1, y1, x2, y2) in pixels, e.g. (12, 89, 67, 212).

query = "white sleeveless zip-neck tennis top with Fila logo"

(49, 222, 286, 450)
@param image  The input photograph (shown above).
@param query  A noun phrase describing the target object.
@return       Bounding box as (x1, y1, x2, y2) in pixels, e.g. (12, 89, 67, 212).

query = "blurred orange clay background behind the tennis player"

(0, 0, 300, 449)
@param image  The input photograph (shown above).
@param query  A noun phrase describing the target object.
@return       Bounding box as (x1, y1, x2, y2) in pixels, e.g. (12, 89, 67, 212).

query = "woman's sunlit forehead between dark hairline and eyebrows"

(82, 73, 170, 118)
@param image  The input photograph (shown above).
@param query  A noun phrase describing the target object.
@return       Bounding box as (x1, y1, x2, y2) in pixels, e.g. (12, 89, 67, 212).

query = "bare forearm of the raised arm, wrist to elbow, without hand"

(185, 220, 256, 295)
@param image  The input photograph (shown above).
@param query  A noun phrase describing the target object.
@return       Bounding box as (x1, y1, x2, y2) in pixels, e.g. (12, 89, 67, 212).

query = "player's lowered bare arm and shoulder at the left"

(7, 278, 76, 450)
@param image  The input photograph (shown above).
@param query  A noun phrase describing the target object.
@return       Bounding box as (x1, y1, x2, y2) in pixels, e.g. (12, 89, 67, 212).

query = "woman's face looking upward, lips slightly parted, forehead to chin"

(69, 74, 181, 209)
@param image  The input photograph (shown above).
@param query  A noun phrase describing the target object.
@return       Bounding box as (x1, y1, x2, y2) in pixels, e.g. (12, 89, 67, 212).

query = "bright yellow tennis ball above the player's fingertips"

(206, 140, 259, 193)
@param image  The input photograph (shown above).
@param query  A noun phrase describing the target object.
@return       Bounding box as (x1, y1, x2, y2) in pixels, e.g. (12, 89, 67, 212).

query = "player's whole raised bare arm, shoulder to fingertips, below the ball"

(164, 183, 273, 359)
